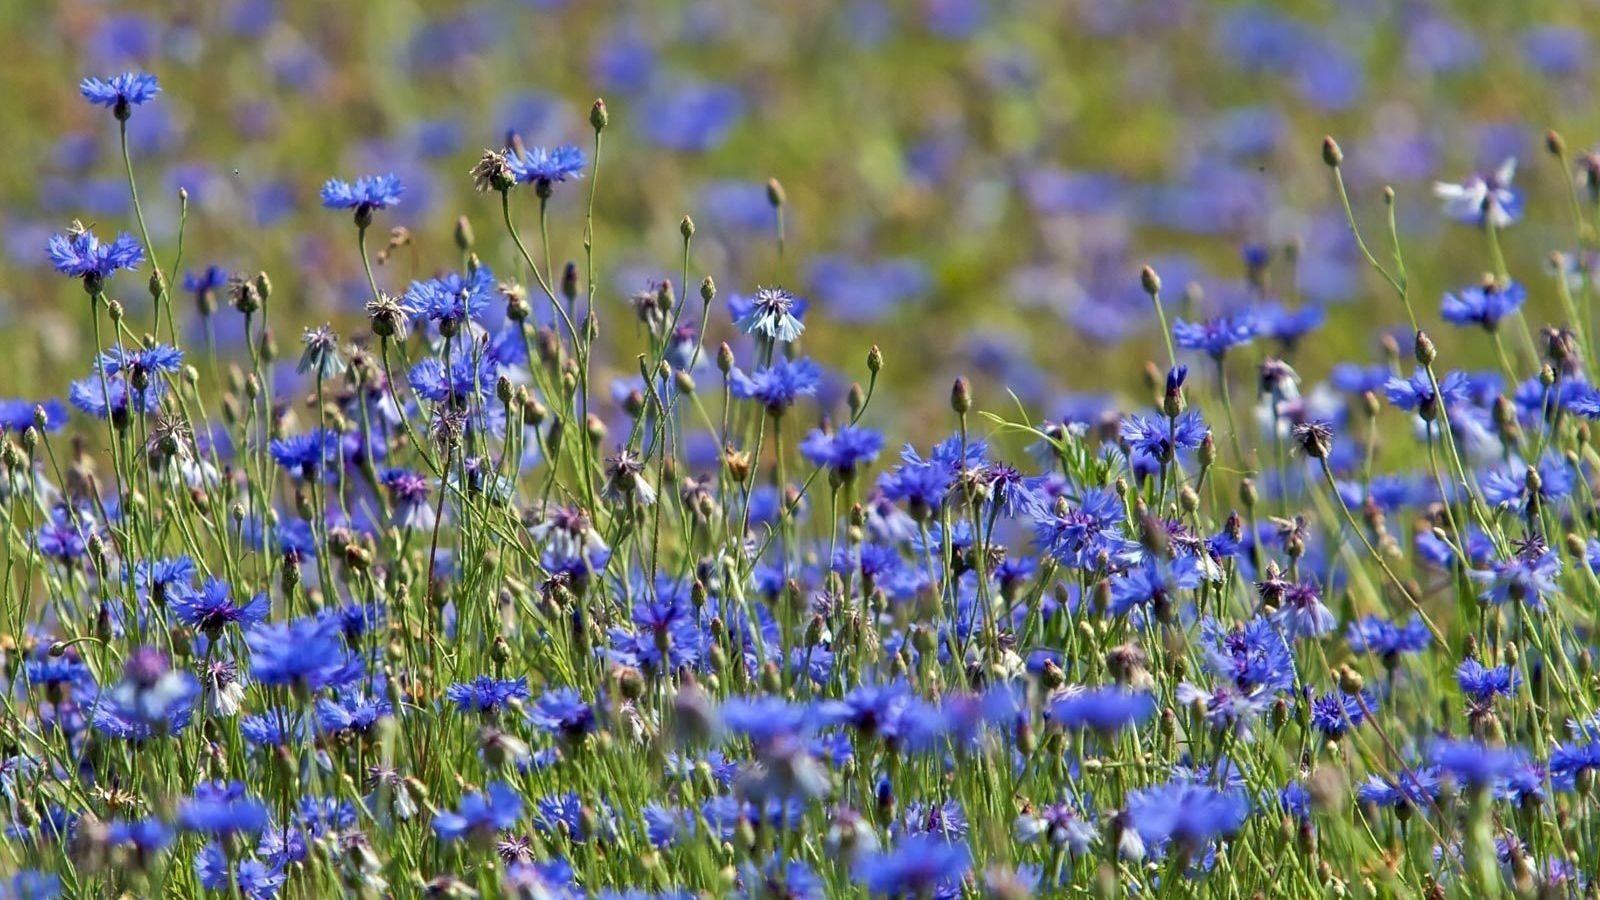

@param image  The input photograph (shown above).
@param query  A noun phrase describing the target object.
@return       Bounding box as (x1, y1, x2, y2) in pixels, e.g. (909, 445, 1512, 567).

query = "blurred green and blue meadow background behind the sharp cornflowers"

(0, 0, 1600, 432)
